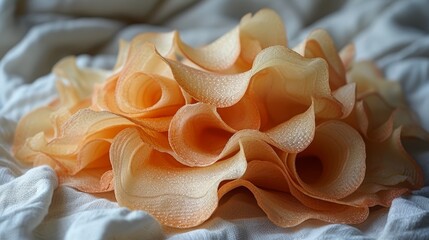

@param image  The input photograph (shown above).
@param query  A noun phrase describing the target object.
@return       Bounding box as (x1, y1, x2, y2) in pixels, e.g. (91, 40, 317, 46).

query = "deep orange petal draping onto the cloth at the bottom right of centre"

(219, 138, 368, 227)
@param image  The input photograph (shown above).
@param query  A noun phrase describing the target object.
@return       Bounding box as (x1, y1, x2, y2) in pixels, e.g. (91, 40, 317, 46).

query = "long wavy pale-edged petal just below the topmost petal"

(164, 46, 337, 110)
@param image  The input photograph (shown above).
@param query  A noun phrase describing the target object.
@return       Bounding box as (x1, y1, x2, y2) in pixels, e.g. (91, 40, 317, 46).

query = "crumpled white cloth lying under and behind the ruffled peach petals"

(0, 0, 429, 239)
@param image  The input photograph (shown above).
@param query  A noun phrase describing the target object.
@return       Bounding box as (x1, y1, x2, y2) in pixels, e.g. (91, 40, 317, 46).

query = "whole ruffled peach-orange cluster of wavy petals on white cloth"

(13, 9, 429, 228)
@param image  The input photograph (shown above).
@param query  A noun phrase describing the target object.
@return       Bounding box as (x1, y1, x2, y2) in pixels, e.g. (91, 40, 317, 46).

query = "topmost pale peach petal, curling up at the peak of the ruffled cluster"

(176, 9, 287, 72)
